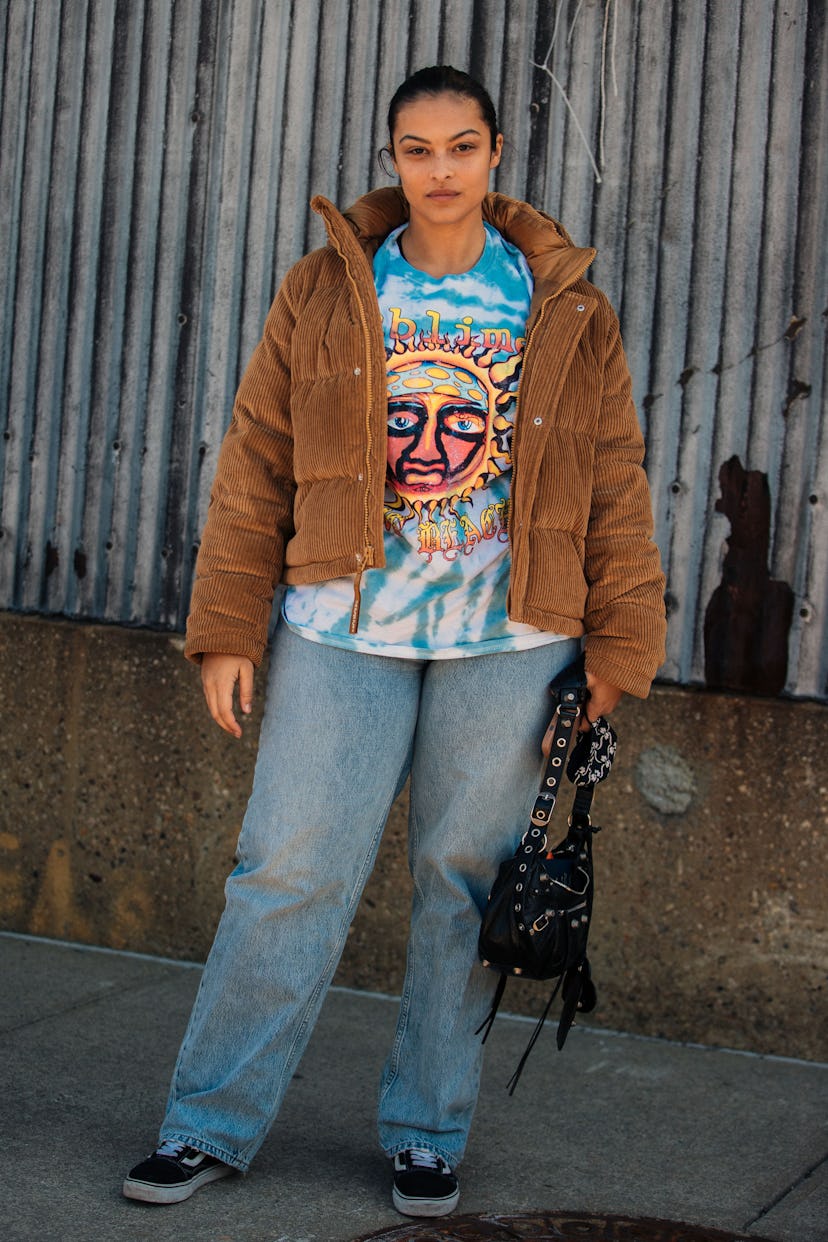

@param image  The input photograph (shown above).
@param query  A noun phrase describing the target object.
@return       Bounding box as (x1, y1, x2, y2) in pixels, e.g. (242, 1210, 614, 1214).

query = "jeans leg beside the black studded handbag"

(379, 640, 580, 1165)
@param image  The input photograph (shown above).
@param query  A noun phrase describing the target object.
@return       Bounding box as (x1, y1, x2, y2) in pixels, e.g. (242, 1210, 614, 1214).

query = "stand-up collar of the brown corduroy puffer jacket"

(310, 186, 596, 299)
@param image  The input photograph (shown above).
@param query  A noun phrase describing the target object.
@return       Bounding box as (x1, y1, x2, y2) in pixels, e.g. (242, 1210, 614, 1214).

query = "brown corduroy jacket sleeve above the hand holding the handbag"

(585, 299, 667, 698)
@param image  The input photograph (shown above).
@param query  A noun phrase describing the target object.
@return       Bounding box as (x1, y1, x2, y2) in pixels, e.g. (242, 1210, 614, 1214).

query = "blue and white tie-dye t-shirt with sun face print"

(283, 225, 557, 660)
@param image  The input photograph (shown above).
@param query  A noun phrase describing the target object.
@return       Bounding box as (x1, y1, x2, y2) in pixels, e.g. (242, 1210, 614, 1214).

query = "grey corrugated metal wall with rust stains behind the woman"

(0, 0, 828, 697)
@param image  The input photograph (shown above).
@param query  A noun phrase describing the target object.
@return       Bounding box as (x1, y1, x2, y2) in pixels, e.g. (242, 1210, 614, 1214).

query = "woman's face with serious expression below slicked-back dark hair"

(391, 93, 503, 233)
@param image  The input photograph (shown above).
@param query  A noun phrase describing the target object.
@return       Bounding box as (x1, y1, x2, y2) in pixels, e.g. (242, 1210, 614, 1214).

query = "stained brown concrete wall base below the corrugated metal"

(0, 614, 828, 1059)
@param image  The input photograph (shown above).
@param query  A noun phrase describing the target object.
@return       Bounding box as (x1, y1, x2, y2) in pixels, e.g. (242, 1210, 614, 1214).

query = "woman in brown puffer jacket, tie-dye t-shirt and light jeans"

(124, 67, 664, 1216)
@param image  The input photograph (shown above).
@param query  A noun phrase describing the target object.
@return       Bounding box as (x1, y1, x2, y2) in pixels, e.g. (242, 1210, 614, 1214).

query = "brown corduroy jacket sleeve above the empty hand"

(185, 268, 304, 664)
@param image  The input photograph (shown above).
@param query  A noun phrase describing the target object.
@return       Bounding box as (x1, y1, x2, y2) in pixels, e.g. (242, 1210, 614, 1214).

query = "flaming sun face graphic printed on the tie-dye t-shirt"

(386, 339, 520, 524)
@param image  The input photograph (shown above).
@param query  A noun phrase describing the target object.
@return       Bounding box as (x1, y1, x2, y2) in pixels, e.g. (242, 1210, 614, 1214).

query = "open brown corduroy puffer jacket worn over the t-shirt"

(185, 189, 665, 697)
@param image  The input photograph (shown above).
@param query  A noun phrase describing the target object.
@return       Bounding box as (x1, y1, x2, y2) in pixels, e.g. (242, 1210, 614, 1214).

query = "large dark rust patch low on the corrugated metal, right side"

(704, 457, 793, 694)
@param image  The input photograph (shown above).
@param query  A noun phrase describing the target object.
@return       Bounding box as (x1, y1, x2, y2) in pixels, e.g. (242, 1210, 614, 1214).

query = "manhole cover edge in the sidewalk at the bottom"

(354, 1212, 768, 1242)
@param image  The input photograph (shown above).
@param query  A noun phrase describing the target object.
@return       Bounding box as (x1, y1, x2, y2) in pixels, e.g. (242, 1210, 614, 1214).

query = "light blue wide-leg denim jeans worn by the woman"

(161, 623, 580, 1171)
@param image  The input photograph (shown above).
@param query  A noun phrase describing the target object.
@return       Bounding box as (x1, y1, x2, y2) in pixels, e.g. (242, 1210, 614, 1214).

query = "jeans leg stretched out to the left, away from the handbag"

(161, 625, 422, 1170)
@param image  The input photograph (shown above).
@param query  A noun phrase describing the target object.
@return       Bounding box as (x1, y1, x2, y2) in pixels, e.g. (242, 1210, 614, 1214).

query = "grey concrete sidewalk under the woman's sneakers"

(0, 934, 828, 1242)
